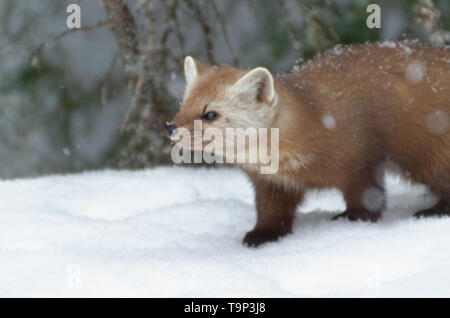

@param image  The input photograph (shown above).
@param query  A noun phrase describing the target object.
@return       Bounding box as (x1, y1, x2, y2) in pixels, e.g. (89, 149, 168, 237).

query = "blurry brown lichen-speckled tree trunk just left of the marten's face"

(102, 0, 173, 168)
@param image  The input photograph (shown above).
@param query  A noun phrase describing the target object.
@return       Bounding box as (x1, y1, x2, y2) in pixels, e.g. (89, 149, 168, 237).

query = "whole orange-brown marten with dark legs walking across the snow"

(166, 41, 450, 246)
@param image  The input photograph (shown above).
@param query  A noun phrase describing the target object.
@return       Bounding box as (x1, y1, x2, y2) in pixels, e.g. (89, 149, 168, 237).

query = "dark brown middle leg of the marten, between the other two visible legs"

(333, 175, 386, 222)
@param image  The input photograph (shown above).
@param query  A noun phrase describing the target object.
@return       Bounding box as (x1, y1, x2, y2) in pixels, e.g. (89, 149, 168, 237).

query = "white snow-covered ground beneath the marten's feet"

(0, 167, 450, 297)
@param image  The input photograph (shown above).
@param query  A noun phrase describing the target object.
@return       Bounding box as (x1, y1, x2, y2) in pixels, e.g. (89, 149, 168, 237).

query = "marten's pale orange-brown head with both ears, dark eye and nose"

(166, 56, 277, 150)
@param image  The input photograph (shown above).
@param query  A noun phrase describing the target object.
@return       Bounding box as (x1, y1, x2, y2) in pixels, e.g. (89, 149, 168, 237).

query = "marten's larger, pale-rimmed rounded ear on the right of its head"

(234, 67, 277, 105)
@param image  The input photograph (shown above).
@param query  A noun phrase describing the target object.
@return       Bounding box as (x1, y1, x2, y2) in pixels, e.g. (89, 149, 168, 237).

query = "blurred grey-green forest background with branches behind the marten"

(0, 0, 450, 179)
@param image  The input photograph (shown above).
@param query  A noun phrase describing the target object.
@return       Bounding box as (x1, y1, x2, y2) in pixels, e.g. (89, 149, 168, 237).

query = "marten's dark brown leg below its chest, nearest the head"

(243, 180, 303, 247)
